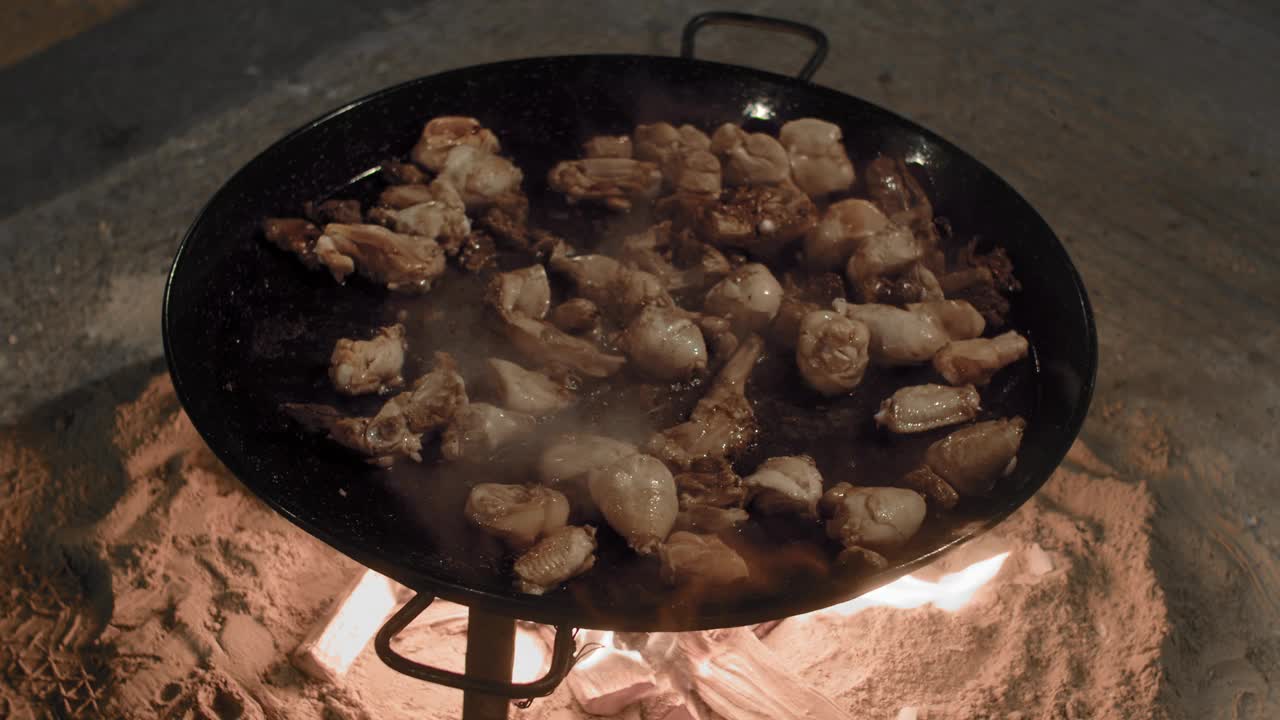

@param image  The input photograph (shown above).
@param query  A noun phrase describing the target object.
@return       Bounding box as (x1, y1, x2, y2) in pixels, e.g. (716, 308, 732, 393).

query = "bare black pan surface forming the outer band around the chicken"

(164, 55, 1096, 630)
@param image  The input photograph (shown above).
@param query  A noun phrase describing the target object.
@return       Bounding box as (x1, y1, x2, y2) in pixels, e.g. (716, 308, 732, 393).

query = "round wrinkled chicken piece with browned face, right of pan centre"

(796, 310, 870, 396)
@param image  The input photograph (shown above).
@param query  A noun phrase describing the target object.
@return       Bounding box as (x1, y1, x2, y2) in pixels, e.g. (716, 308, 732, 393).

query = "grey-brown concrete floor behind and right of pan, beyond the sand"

(0, 0, 1280, 719)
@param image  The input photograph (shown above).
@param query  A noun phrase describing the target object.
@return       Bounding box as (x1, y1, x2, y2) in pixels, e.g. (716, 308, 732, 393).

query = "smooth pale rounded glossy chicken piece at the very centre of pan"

(618, 305, 707, 380)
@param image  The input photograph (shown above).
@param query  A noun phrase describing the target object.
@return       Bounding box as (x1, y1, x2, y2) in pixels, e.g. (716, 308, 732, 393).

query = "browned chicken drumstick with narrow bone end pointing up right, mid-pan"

(645, 334, 764, 469)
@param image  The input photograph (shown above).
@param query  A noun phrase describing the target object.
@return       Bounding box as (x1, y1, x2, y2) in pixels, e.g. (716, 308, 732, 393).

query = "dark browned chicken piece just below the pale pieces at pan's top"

(694, 182, 818, 260)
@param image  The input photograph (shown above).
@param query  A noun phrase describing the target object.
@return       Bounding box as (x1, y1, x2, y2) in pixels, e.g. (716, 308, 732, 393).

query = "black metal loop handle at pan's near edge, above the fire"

(374, 593, 575, 698)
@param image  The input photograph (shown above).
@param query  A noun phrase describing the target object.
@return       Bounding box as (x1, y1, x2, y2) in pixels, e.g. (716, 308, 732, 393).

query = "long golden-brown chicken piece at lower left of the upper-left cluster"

(315, 223, 444, 293)
